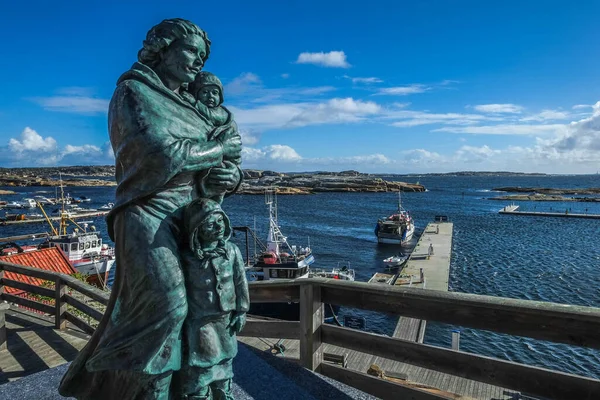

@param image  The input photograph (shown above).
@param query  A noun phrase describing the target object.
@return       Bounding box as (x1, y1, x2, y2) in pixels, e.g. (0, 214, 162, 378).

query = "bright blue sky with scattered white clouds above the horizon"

(0, 0, 600, 173)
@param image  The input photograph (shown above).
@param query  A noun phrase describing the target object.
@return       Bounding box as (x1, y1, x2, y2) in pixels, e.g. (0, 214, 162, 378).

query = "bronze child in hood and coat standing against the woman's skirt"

(179, 198, 250, 400)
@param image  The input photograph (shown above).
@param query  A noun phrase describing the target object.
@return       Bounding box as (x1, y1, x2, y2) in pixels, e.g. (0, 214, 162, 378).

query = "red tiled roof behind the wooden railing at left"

(0, 247, 76, 295)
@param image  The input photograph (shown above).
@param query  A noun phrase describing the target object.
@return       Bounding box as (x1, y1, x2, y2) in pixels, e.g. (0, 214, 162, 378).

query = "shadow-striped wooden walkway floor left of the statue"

(0, 306, 89, 384)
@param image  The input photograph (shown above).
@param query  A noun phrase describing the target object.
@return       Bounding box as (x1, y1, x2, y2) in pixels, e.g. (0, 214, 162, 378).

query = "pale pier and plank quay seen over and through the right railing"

(239, 222, 519, 399)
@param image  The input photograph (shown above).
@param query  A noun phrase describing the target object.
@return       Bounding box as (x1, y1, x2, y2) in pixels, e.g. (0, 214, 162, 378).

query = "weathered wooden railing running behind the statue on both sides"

(0, 262, 600, 400)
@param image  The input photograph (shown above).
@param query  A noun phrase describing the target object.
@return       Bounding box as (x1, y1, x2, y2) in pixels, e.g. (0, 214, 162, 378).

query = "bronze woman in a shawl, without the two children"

(59, 19, 241, 399)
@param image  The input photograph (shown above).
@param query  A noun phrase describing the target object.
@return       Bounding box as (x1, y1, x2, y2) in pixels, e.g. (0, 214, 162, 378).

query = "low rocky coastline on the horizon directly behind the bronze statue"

(0, 165, 426, 194)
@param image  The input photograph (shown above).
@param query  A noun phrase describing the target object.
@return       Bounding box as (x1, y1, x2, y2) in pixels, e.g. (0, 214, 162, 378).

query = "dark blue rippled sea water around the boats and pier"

(0, 175, 600, 378)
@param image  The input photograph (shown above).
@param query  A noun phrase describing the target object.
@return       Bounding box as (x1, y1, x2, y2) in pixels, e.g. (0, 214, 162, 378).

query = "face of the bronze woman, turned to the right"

(161, 35, 206, 83)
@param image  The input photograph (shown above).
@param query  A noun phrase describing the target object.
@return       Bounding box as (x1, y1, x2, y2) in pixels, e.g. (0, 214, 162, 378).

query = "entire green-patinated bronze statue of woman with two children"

(60, 19, 248, 400)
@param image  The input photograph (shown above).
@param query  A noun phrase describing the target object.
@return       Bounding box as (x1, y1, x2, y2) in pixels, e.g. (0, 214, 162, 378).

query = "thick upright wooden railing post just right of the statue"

(300, 283, 325, 372)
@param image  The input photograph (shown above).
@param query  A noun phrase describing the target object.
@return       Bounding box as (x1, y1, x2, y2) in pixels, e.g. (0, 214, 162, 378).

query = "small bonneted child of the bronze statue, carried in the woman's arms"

(188, 71, 242, 203)
